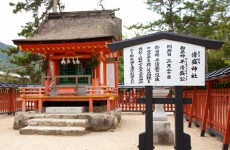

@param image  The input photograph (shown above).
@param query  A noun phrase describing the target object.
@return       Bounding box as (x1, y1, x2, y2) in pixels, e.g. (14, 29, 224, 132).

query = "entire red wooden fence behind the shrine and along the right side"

(0, 81, 230, 145)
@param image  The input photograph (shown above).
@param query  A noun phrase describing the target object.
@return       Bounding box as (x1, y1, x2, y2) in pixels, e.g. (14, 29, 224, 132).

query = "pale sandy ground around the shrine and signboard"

(0, 113, 227, 150)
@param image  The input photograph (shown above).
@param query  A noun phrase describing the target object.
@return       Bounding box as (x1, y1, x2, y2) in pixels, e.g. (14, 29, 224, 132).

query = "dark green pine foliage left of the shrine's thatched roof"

(5, 0, 64, 83)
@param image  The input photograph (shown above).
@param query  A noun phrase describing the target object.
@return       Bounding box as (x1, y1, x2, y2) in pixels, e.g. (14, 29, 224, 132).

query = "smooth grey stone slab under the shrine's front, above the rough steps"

(46, 107, 85, 113)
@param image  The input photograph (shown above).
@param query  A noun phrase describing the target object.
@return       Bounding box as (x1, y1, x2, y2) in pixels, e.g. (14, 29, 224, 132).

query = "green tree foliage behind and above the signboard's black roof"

(128, 0, 230, 71)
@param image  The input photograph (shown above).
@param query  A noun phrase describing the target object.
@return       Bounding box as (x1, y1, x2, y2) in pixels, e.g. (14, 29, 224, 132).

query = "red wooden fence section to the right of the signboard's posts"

(184, 82, 230, 149)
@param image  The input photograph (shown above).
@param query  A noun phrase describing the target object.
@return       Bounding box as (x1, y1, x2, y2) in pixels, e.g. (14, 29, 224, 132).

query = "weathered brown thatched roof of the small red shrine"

(13, 10, 122, 44)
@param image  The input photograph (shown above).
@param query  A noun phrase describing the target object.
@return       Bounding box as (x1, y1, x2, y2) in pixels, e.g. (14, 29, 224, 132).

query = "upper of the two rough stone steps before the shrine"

(28, 118, 88, 128)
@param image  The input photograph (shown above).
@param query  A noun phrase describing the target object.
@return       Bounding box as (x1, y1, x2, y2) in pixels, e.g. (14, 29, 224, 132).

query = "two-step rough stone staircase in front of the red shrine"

(19, 115, 88, 136)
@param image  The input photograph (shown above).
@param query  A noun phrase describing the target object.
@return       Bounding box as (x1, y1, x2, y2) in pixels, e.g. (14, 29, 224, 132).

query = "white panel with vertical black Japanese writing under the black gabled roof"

(124, 40, 205, 86)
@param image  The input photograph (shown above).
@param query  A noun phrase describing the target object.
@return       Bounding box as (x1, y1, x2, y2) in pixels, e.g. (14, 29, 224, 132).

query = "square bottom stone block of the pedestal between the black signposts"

(153, 132, 174, 145)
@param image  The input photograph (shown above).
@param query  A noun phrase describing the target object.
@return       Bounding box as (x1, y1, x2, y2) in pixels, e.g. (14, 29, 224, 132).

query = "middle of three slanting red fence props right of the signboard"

(200, 82, 212, 136)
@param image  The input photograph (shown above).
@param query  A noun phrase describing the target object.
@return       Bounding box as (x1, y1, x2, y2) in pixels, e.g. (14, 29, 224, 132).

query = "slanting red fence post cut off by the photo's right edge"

(222, 96, 230, 150)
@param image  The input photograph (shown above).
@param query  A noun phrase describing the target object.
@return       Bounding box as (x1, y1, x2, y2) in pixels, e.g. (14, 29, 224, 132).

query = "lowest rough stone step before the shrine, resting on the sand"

(19, 126, 86, 136)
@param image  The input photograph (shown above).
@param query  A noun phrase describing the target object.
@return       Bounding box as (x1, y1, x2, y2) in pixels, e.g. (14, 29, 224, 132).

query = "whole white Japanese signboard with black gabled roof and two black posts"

(108, 32, 224, 150)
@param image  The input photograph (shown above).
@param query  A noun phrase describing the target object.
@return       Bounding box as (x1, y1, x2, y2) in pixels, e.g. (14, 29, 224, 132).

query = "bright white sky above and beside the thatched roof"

(0, 0, 156, 45)
